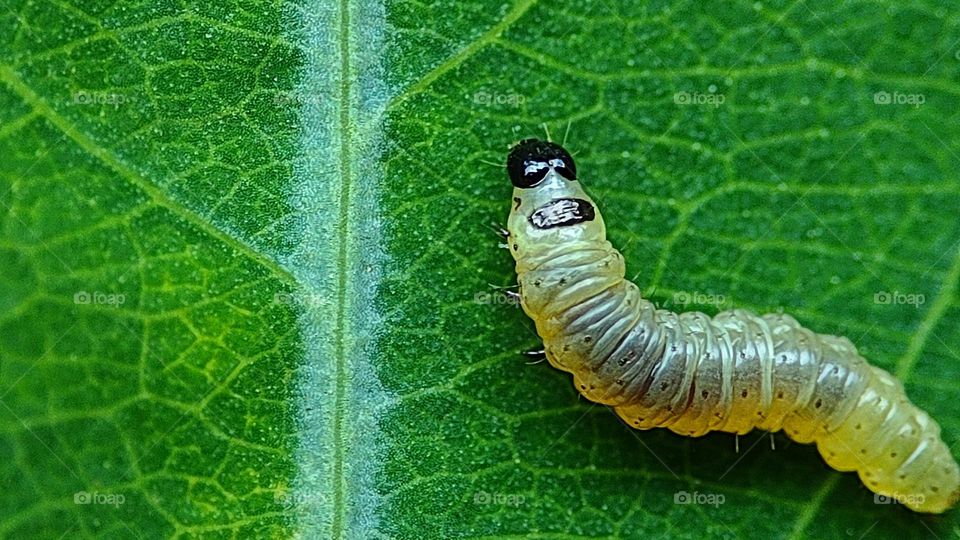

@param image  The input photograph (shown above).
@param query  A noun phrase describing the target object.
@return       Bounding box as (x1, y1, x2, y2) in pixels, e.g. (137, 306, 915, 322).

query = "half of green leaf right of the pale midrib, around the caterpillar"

(378, 2, 960, 538)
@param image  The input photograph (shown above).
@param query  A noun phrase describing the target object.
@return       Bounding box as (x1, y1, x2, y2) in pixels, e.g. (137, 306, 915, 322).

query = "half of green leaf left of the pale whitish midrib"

(0, 2, 307, 538)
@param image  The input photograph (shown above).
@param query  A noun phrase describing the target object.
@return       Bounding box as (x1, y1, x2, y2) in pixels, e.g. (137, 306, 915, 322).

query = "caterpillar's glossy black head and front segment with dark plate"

(507, 139, 606, 259)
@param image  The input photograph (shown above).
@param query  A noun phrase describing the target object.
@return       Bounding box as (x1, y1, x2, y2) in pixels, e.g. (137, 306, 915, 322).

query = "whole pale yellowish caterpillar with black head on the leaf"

(503, 139, 960, 513)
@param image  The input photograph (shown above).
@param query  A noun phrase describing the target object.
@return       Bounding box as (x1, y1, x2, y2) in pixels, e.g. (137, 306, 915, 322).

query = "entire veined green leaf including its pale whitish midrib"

(0, 0, 960, 538)
